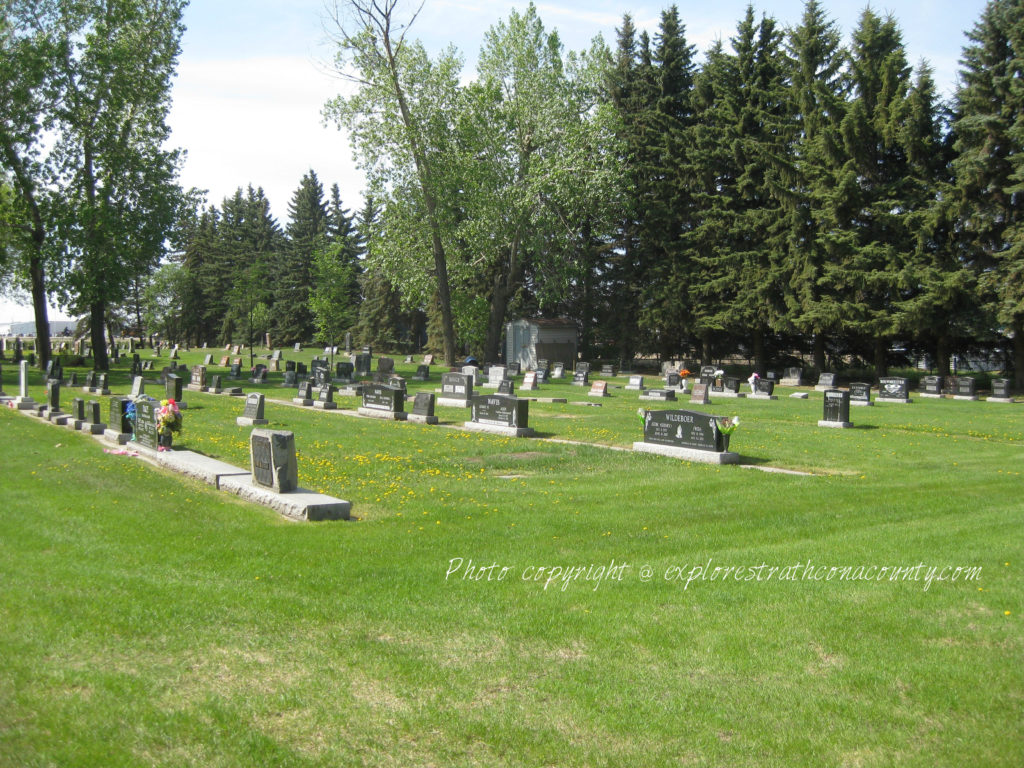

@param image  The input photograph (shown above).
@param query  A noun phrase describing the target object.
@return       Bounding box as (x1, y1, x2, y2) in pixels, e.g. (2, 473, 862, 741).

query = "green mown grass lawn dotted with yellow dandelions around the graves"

(0, 351, 1024, 768)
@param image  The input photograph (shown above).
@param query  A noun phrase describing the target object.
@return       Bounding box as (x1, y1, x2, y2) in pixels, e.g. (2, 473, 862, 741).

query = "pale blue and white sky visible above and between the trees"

(0, 0, 985, 325)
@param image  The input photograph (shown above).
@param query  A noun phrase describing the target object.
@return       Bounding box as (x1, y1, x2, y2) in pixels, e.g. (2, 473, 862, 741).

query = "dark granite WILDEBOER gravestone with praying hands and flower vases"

(633, 411, 739, 464)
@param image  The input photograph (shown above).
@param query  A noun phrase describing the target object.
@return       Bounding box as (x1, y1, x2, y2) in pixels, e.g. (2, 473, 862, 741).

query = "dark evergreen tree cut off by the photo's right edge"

(953, 0, 1024, 389)
